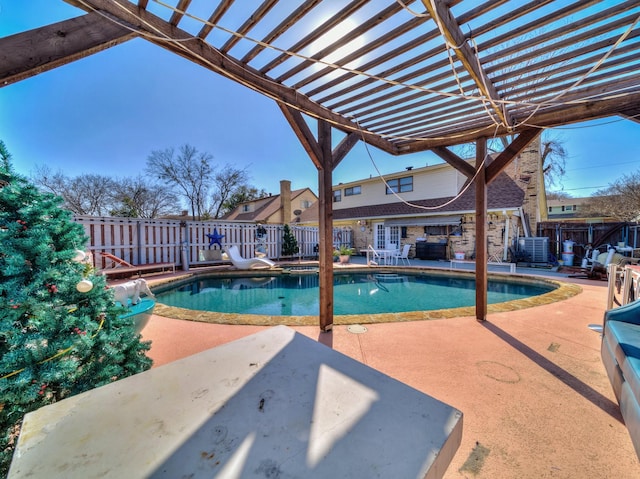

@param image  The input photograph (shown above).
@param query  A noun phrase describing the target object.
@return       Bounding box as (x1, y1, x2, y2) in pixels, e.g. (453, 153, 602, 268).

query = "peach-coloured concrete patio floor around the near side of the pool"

(143, 263, 640, 478)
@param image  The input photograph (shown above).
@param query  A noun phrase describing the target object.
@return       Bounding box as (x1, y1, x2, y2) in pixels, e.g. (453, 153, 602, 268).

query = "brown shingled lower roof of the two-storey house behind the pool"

(300, 173, 524, 222)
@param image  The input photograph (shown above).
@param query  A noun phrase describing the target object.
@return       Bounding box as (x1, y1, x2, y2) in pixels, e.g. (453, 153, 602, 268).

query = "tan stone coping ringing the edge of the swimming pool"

(150, 266, 582, 326)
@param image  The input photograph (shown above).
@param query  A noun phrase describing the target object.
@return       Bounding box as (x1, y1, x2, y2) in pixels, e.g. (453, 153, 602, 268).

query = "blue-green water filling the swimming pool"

(154, 273, 555, 316)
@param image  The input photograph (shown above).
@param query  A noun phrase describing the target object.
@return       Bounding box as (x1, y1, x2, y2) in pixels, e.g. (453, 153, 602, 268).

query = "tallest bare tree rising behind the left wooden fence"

(147, 144, 213, 220)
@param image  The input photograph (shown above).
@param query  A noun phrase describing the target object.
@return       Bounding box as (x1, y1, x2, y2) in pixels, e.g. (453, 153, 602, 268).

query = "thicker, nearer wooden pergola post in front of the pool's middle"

(318, 121, 333, 332)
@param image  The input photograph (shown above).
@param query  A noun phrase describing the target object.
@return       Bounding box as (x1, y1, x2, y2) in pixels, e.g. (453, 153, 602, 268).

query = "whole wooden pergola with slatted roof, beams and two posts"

(0, 0, 640, 331)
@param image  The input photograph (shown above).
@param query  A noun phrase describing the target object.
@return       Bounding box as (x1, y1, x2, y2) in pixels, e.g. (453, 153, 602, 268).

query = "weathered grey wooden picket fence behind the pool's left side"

(74, 216, 353, 268)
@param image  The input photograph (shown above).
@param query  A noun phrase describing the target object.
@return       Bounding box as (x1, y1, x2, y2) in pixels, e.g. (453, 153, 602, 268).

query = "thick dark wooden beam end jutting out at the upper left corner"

(0, 13, 137, 87)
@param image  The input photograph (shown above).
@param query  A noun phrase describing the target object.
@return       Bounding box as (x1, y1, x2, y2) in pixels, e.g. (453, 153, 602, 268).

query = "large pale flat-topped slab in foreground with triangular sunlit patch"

(9, 326, 462, 479)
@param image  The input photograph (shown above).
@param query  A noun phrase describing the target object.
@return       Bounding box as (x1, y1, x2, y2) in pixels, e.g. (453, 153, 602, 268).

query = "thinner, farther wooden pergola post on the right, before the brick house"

(475, 138, 488, 321)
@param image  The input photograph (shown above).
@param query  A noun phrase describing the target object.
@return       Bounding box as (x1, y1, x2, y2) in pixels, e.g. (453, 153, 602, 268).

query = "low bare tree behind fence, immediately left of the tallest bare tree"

(111, 175, 178, 218)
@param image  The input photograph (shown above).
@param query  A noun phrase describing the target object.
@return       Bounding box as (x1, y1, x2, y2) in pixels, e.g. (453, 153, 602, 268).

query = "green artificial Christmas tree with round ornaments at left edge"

(0, 141, 151, 477)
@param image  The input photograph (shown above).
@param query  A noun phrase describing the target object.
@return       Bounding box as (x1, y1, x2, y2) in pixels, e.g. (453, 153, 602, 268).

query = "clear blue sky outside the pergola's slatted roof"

(0, 0, 640, 197)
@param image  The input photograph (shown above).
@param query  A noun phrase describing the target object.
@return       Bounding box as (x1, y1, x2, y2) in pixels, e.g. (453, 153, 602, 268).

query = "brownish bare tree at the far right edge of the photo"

(584, 170, 640, 221)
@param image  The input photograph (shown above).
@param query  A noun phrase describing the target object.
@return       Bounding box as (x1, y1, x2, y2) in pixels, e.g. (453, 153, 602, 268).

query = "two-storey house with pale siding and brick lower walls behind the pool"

(301, 140, 546, 260)
